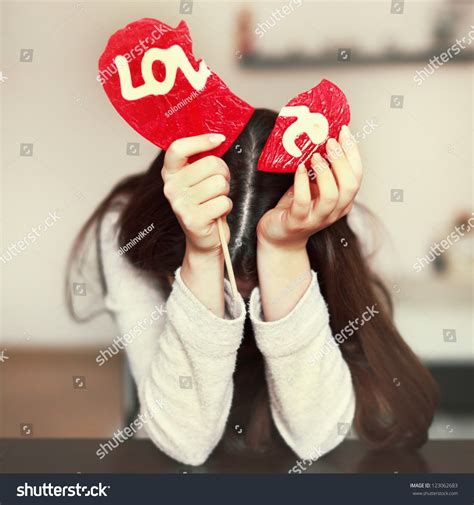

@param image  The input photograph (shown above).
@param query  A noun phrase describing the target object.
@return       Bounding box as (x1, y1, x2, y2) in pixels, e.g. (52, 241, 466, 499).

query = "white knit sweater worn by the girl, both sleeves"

(100, 211, 355, 465)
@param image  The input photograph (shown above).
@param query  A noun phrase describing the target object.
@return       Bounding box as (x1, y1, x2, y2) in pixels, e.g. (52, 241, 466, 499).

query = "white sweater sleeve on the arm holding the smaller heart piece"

(250, 272, 355, 460)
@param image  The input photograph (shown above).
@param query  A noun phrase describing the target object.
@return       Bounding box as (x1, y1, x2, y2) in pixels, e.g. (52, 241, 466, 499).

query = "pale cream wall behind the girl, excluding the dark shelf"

(0, 1, 473, 345)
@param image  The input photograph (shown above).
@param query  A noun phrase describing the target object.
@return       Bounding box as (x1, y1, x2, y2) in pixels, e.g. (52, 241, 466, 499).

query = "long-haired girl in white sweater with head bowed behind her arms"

(66, 109, 437, 465)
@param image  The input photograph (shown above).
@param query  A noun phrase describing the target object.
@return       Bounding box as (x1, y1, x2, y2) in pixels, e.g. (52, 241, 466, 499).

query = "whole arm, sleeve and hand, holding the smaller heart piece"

(256, 126, 362, 459)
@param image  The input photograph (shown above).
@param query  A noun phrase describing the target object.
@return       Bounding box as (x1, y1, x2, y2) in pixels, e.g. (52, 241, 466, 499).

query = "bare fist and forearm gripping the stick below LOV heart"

(161, 134, 232, 317)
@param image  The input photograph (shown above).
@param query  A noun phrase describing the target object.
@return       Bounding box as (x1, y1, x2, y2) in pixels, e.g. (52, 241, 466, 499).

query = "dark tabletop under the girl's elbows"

(0, 438, 474, 473)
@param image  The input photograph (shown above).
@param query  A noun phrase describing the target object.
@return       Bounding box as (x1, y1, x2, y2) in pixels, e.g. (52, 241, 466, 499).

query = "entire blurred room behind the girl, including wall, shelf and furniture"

(0, 0, 474, 439)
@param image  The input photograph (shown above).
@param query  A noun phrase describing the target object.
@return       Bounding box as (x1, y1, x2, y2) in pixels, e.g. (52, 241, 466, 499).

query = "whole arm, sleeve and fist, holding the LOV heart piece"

(96, 134, 245, 465)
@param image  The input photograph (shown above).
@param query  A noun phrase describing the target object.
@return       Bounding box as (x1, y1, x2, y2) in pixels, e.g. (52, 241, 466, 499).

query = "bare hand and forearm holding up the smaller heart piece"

(257, 126, 362, 321)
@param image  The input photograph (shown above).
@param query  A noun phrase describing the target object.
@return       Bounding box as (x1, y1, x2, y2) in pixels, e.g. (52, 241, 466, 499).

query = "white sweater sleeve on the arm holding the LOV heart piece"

(100, 211, 245, 465)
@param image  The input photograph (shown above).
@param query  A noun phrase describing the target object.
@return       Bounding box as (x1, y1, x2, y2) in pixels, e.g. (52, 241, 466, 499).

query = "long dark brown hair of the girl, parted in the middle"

(68, 109, 437, 448)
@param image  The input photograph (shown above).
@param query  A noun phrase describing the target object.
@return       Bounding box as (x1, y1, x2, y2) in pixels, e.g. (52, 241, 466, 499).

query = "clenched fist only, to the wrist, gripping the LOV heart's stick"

(161, 133, 232, 253)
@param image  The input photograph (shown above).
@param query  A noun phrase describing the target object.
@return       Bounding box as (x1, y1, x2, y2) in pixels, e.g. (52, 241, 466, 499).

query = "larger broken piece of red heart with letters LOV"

(97, 19, 254, 159)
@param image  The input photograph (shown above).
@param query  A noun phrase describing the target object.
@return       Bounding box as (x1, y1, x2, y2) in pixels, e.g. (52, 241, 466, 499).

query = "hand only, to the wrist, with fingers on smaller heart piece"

(257, 126, 362, 249)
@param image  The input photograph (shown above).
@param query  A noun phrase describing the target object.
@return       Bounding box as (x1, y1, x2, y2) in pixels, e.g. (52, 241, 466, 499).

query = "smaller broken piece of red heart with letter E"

(258, 79, 350, 173)
